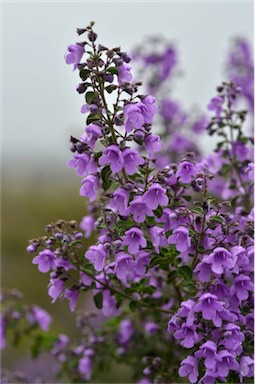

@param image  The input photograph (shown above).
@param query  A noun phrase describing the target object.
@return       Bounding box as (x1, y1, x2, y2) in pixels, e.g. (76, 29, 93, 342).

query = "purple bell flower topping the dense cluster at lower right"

(195, 293, 224, 327)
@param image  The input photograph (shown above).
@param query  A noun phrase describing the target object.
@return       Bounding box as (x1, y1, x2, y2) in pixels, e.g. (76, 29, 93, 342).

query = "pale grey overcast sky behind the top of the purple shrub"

(2, 1, 253, 174)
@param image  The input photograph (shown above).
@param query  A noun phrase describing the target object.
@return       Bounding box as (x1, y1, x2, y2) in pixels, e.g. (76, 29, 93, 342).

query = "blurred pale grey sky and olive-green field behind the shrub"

(1, 1, 253, 382)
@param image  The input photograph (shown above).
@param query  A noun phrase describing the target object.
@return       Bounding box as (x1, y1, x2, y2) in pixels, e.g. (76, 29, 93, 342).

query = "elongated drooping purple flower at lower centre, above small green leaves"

(114, 251, 136, 283)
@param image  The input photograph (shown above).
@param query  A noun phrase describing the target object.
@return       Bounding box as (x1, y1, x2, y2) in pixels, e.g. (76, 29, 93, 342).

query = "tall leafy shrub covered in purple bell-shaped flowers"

(2, 23, 253, 384)
